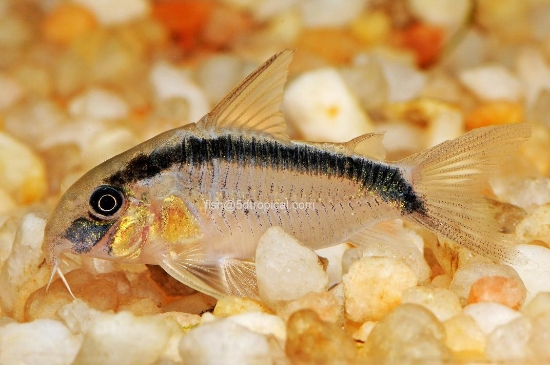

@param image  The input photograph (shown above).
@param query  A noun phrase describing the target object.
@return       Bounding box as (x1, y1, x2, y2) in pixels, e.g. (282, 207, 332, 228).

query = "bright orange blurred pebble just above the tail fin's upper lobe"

(466, 101, 523, 130)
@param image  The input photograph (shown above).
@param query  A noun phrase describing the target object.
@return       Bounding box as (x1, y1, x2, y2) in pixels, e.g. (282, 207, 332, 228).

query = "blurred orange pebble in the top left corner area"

(42, 3, 97, 44)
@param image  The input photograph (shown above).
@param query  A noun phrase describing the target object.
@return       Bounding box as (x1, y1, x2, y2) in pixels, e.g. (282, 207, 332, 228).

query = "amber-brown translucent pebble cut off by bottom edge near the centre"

(285, 309, 356, 365)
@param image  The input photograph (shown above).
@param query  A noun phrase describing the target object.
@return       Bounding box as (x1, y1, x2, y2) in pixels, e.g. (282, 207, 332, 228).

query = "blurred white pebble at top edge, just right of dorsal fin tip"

(301, 0, 370, 27)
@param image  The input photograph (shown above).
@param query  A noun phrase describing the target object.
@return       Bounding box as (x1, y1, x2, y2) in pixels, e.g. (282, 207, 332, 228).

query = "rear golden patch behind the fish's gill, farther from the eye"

(158, 195, 201, 244)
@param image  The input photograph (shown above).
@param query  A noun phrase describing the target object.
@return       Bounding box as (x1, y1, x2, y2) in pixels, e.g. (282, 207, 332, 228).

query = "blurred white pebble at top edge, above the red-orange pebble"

(408, 0, 473, 27)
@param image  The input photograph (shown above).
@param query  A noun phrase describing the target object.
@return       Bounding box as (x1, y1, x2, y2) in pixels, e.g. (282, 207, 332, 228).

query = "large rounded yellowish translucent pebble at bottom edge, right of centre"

(366, 304, 452, 364)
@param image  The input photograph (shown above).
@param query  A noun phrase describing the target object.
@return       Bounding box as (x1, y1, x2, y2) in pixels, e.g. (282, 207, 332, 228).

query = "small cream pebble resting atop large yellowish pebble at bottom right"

(401, 287, 462, 322)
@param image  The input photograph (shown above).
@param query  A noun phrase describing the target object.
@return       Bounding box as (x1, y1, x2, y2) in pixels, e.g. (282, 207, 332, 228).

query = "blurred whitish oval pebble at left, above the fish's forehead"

(68, 89, 129, 120)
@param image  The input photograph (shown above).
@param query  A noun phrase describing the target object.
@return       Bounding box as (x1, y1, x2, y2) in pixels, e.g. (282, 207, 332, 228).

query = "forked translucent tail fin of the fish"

(400, 124, 531, 263)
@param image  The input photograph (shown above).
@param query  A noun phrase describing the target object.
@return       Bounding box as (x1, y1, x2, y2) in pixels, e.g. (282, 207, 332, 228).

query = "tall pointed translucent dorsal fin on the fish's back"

(197, 50, 293, 143)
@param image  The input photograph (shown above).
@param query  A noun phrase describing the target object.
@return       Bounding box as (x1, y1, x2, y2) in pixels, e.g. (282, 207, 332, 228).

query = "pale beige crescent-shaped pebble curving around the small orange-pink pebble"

(449, 260, 523, 304)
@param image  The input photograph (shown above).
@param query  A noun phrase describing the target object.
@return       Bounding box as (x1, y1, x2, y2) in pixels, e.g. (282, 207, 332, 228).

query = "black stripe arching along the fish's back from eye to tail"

(106, 135, 425, 214)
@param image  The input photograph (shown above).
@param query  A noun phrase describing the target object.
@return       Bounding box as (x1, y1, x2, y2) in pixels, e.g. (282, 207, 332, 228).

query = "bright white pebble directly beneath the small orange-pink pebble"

(464, 302, 521, 335)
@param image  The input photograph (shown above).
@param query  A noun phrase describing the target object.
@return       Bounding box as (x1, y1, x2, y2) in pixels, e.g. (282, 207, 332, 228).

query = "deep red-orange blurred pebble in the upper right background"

(401, 23, 445, 67)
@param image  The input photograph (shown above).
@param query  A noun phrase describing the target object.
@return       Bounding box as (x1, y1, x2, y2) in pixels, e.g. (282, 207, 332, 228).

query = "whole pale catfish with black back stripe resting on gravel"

(43, 50, 531, 298)
